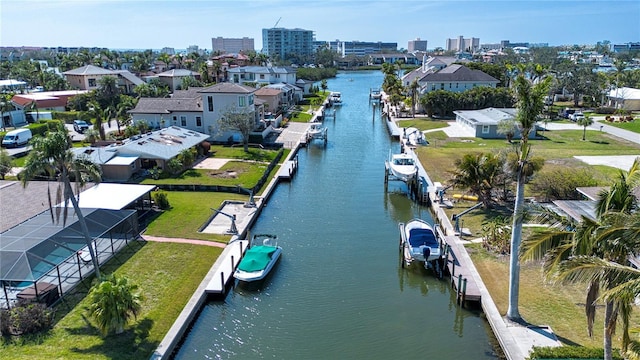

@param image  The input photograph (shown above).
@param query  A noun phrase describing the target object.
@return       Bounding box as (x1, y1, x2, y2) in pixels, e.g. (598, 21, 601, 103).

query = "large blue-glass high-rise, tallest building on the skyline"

(262, 28, 314, 59)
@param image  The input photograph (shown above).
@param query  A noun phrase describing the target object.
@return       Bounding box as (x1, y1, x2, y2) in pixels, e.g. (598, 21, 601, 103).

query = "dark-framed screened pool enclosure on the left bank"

(0, 208, 139, 307)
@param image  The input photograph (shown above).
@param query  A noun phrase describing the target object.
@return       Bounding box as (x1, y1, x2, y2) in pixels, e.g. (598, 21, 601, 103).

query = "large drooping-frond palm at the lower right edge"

(521, 159, 640, 359)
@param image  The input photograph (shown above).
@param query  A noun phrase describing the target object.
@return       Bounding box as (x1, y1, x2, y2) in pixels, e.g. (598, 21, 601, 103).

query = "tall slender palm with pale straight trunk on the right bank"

(507, 73, 551, 321)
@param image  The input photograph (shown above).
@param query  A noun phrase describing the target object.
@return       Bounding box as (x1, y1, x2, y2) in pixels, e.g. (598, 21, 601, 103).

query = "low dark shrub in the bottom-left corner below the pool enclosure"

(0, 303, 53, 335)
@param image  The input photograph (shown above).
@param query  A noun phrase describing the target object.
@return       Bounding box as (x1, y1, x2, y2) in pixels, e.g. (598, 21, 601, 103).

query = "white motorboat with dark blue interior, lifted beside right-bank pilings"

(399, 219, 443, 269)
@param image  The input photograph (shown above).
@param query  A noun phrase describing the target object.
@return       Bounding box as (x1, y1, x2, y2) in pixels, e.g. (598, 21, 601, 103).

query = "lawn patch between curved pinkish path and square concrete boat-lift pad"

(145, 191, 249, 243)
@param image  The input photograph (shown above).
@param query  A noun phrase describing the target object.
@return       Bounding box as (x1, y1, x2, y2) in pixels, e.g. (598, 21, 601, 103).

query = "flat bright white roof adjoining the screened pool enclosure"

(58, 183, 156, 210)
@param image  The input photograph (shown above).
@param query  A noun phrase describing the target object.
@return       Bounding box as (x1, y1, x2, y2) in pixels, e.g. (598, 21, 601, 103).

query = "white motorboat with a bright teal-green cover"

(233, 234, 282, 282)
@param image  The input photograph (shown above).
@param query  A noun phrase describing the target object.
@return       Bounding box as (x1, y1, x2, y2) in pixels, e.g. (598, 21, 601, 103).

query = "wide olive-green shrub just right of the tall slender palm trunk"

(530, 168, 598, 202)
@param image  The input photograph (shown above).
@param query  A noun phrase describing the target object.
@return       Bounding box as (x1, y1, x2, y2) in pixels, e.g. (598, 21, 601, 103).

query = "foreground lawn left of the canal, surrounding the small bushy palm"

(0, 242, 222, 360)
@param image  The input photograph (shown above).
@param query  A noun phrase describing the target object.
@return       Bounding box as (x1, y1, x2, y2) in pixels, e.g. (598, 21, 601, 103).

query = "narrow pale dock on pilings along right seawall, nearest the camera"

(441, 232, 482, 306)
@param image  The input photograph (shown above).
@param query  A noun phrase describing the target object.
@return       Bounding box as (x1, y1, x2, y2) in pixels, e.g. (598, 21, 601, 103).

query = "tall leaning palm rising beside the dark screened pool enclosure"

(21, 125, 101, 278)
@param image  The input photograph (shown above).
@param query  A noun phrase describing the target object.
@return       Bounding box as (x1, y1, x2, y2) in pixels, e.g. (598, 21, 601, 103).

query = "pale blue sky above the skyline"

(0, 0, 640, 51)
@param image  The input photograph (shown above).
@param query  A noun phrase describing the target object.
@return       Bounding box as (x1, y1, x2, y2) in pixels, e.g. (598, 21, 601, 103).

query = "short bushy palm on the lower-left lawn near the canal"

(89, 274, 142, 334)
